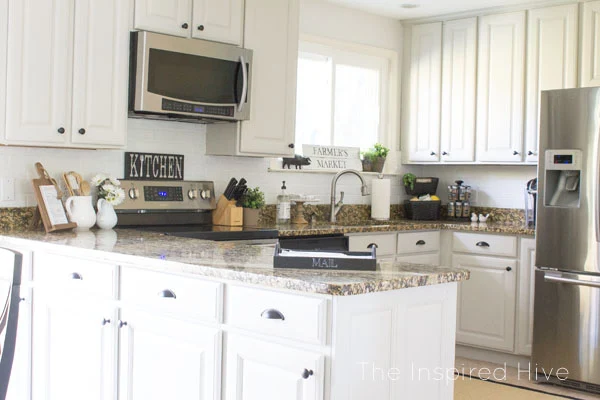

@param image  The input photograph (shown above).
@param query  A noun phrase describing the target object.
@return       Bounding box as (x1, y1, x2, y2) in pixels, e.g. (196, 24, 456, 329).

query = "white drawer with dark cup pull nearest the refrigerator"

(452, 232, 517, 257)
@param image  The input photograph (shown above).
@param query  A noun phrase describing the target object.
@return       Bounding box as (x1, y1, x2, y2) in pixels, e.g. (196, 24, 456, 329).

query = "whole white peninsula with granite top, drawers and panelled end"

(0, 229, 469, 400)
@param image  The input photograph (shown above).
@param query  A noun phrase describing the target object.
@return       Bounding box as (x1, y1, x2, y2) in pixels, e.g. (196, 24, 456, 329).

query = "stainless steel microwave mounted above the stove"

(129, 31, 252, 122)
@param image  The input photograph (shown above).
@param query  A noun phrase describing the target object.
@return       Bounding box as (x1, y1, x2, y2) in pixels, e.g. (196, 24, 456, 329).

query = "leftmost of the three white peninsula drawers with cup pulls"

(33, 252, 117, 298)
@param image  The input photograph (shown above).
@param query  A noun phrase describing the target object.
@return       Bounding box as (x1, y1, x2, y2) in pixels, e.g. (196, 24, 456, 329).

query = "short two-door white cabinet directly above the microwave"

(134, 0, 244, 45)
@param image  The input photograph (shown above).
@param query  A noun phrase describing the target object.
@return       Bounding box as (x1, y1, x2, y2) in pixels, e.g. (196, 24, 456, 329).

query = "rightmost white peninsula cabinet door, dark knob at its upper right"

(224, 335, 324, 400)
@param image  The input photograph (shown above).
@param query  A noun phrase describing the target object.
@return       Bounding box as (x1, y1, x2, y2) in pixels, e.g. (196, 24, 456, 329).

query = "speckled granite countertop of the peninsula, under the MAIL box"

(2, 228, 469, 296)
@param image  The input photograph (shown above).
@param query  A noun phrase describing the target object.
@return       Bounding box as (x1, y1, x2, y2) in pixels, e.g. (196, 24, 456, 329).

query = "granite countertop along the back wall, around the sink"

(274, 219, 535, 236)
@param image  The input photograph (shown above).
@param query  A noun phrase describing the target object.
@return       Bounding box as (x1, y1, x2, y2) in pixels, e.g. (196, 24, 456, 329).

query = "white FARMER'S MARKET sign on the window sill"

(302, 144, 362, 171)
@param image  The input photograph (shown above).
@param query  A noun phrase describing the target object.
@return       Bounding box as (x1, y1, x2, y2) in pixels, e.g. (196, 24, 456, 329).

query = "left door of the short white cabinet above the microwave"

(134, 0, 192, 37)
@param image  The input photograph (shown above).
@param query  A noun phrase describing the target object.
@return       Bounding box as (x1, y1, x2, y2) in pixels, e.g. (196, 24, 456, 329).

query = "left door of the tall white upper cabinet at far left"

(6, 0, 74, 146)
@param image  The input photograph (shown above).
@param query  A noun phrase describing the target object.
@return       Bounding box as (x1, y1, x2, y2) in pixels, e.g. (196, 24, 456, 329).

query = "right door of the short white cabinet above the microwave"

(192, 0, 244, 45)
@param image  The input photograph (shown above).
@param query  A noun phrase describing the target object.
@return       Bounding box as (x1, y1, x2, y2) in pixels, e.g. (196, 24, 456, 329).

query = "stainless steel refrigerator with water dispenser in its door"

(530, 88, 600, 391)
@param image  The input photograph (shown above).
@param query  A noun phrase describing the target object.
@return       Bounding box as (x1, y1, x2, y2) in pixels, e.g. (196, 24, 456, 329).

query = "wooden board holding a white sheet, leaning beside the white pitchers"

(32, 162, 77, 233)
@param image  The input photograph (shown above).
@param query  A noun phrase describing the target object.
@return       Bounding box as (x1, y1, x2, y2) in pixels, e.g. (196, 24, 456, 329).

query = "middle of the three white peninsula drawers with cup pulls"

(121, 268, 222, 322)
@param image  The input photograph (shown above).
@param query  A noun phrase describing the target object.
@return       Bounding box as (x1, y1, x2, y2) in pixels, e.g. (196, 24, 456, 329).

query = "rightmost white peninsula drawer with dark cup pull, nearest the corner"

(225, 286, 327, 344)
